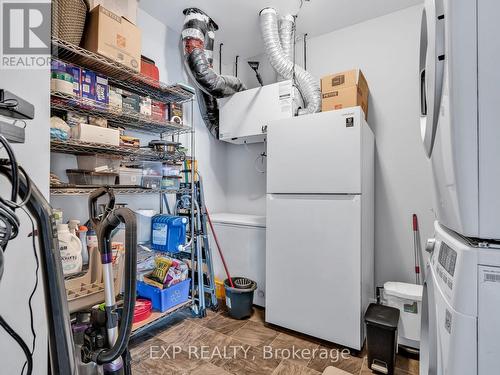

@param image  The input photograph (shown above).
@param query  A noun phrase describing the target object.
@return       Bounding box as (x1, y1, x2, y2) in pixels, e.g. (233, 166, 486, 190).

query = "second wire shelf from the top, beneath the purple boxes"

(50, 91, 191, 135)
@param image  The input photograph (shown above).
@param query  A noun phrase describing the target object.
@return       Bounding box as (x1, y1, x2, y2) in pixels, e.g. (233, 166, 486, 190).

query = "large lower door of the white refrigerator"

(266, 194, 363, 350)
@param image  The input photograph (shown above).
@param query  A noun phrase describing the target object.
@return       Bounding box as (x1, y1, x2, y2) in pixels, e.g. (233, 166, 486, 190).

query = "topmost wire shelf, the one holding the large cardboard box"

(52, 37, 194, 103)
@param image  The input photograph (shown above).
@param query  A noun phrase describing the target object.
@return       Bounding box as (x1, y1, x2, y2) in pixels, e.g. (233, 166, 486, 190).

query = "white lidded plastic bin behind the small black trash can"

(384, 281, 423, 349)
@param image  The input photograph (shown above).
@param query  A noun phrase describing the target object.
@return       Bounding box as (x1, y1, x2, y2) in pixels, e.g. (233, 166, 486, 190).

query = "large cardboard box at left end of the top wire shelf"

(82, 5, 141, 72)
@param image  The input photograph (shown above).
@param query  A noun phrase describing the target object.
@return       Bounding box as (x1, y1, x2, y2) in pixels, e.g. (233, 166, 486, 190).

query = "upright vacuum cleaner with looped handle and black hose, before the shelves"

(77, 187, 137, 375)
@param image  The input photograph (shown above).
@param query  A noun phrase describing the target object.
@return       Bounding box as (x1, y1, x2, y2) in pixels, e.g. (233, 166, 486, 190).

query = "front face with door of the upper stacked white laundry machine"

(420, 0, 480, 237)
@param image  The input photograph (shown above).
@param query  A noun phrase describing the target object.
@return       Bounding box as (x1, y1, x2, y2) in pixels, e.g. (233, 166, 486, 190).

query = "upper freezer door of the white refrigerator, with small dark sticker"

(267, 107, 369, 194)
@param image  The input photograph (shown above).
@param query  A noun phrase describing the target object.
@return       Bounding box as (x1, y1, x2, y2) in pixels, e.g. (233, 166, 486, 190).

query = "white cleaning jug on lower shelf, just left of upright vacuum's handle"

(57, 224, 82, 276)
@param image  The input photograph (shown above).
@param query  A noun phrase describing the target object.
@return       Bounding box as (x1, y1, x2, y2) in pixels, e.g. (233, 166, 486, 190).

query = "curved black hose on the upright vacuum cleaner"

(94, 208, 137, 365)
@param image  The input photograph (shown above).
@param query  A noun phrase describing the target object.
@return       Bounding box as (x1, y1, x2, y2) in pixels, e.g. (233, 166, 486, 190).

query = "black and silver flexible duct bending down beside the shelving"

(182, 8, 246, 138)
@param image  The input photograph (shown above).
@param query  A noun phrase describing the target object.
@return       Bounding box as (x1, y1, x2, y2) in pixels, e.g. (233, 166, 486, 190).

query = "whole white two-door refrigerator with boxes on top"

(266, 107, 375, 350)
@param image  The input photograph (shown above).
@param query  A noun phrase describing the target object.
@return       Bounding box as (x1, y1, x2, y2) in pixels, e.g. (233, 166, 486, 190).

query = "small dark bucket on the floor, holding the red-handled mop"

(224, 277, 257, 319)
